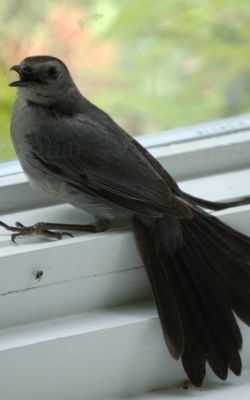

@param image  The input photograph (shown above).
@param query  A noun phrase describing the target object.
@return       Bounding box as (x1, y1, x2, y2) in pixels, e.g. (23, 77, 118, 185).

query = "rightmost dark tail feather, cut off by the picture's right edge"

(188, 209, 250, 325)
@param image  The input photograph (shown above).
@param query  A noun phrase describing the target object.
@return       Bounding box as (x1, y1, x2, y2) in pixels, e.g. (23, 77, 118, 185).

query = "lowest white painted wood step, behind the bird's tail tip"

(0, 303, 250, 400)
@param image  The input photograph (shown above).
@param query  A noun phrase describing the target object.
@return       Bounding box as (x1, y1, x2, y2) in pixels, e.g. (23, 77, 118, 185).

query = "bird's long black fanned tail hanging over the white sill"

(134, 209, 250, 386)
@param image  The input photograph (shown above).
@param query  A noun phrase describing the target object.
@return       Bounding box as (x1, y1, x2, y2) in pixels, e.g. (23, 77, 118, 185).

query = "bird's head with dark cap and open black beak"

(9, 56, 76, 104)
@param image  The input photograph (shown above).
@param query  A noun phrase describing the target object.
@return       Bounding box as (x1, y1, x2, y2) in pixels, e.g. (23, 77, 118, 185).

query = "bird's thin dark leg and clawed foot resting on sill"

(0, 219, 110, 243)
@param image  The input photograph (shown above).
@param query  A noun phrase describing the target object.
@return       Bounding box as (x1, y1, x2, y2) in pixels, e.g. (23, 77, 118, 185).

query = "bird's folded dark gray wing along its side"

(26, 112, 190, 217)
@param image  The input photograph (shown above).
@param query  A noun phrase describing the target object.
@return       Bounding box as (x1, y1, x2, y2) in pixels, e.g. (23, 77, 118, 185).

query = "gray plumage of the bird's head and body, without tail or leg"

(11, 57, 188, 225)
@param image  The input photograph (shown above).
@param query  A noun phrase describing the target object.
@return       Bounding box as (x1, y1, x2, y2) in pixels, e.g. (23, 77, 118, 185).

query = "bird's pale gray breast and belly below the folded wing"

(11, 98, 130, 220)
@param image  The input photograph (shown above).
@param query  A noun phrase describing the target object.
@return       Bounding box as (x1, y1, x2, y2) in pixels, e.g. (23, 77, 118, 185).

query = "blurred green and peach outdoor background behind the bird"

(0, 0, 250, 161)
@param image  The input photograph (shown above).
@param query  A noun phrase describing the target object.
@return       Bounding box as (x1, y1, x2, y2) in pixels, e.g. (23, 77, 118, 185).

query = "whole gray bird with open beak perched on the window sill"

(1, 56, 250, 386)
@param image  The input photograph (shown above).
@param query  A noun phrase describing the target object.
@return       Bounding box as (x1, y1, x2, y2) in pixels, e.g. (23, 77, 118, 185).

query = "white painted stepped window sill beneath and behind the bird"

(0, 114, 250, 400)
